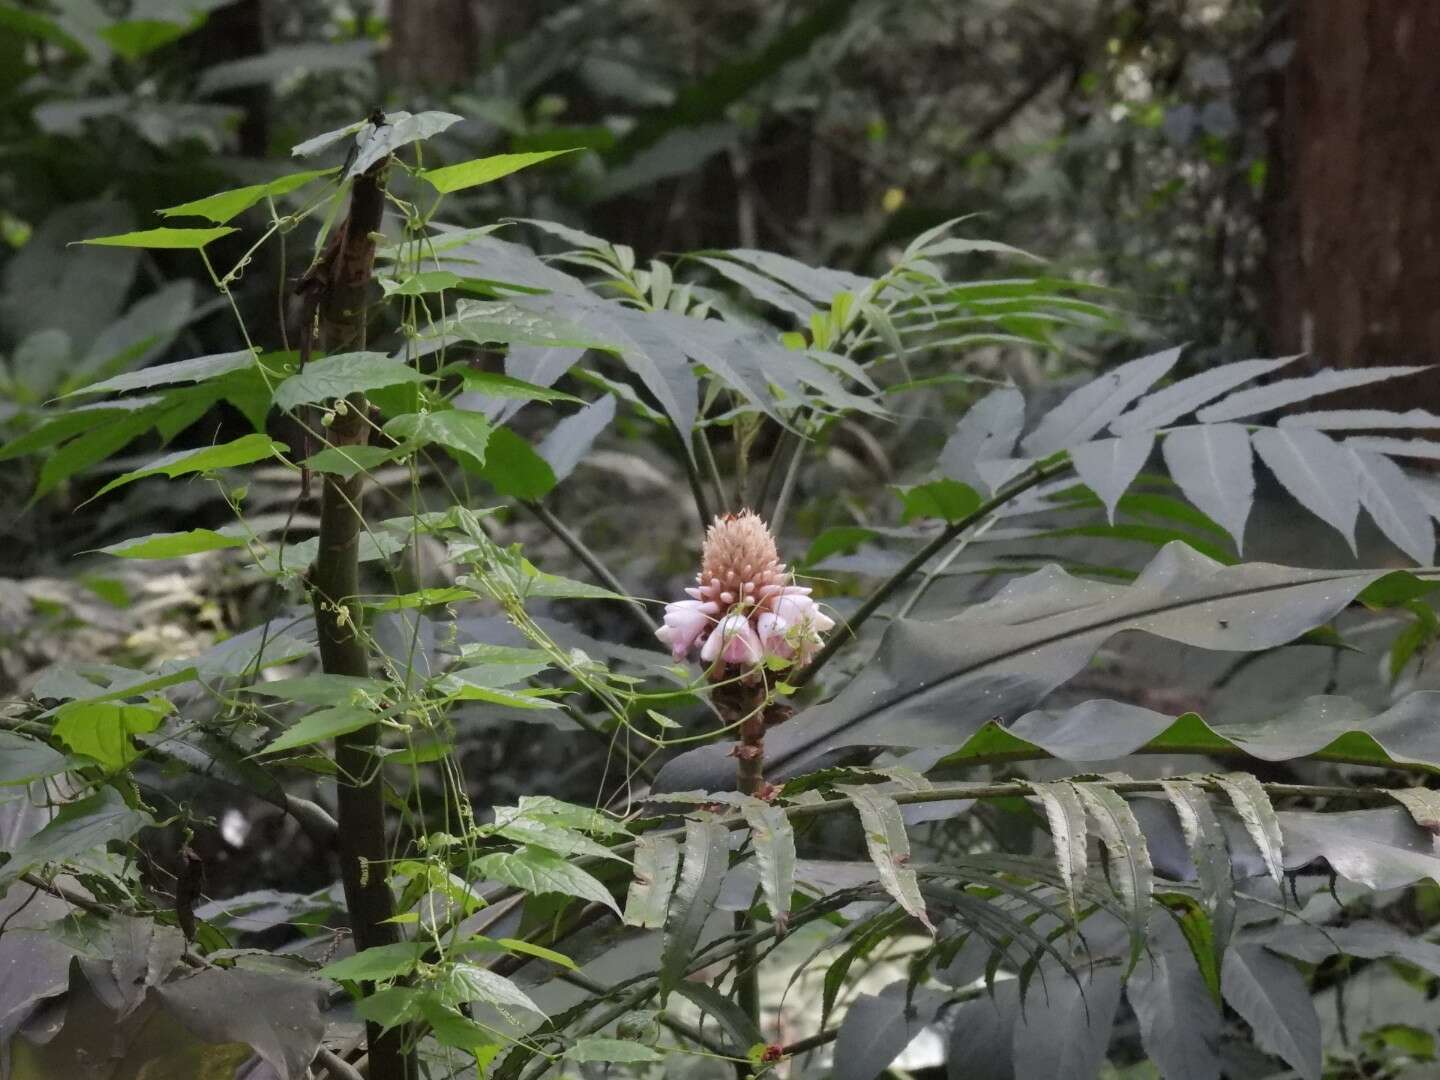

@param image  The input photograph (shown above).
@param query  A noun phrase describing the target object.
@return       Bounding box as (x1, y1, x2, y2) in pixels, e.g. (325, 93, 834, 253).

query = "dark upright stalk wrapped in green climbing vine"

(301, 158, 415, 1080)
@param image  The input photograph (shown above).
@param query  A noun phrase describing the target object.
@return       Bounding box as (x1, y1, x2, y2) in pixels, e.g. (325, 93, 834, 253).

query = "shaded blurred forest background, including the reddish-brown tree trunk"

(0, 0, 1440, 403)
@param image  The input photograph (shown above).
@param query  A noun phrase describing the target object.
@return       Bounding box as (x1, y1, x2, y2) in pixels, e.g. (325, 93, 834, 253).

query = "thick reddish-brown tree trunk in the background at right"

(1266, 0, 1440, 410)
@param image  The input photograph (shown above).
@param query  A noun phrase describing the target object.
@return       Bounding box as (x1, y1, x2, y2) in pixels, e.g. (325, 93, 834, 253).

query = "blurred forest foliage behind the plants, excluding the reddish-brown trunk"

(0, 0, 1307, 576)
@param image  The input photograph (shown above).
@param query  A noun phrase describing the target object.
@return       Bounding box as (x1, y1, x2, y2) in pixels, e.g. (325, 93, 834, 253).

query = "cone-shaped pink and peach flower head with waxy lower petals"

(655, 510, 835, 675)
